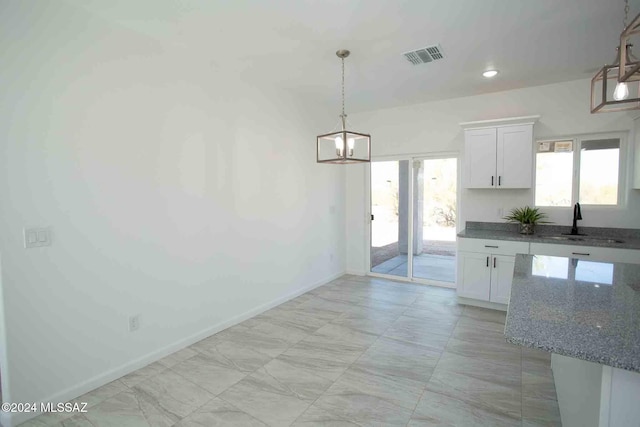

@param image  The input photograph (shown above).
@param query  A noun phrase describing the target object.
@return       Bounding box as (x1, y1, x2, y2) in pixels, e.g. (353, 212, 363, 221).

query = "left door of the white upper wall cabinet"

(464, 128, 497, 188)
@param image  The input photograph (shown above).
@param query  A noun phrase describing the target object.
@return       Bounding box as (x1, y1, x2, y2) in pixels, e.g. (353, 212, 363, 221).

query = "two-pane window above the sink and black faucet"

(535, 135, 622, 207)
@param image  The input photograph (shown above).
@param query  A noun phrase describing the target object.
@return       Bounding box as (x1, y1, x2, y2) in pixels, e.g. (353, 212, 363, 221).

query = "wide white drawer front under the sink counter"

(530, 243, 640, 264)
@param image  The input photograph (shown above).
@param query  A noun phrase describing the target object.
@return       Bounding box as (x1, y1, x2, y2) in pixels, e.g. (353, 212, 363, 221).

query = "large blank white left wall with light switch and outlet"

(0, 1, 346, 422)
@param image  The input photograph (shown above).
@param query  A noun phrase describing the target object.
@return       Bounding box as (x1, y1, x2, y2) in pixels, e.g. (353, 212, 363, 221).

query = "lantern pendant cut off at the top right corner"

(591, 0, 640, 113)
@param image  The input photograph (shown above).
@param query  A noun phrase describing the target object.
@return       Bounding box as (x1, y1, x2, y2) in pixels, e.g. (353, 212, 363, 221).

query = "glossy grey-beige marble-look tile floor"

(23, 276, 560, 427)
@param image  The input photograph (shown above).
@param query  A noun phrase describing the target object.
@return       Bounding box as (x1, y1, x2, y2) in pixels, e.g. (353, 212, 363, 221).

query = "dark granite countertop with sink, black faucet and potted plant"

(458, 221, 640, 249)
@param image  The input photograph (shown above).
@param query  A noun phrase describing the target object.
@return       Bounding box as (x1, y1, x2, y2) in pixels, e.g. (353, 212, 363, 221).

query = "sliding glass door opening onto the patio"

(370, 156, 458, 285)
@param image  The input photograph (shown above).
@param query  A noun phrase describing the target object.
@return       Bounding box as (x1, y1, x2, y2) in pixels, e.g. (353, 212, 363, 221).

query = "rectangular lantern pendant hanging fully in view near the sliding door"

(316, 50, 371, 164)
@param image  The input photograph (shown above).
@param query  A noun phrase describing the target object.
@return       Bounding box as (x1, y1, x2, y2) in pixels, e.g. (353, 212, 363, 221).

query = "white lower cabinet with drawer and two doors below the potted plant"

(457, 239, 529, 304)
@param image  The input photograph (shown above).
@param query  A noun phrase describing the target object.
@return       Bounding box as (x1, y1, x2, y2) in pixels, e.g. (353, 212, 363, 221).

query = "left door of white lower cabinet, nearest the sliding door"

(457, 252, 491, 301)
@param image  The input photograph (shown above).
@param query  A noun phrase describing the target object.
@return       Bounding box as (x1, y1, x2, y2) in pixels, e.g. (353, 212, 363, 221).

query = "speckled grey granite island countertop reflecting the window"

(505, 254, 640, 372)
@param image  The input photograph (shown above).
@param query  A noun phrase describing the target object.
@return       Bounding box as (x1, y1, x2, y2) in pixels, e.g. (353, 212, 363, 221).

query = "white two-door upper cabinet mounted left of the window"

(462, 116, 538, 189)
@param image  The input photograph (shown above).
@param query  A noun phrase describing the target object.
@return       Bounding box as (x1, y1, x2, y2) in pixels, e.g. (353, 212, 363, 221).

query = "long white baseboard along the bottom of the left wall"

(0, 271, 345, 427)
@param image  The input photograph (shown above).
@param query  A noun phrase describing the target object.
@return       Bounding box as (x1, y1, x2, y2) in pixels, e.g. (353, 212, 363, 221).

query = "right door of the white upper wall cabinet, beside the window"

(496, 125, 533, 188)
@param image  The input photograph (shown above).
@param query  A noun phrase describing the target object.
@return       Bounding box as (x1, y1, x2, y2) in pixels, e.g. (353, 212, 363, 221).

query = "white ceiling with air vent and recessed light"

(63, 0, 640, 112)
